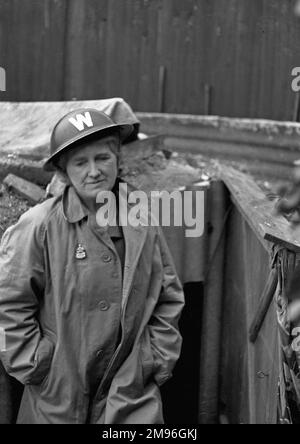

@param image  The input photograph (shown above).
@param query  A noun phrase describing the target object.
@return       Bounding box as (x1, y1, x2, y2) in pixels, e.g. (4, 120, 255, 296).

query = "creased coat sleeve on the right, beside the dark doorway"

(148, 231, 184, 385)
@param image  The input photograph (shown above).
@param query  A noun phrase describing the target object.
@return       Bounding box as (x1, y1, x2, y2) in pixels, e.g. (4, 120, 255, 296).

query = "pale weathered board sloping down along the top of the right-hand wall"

(220, 166, 300, 253)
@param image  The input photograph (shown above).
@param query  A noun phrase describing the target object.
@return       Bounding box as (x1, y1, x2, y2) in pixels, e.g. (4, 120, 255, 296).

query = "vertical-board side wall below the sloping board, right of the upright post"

(220, 209, 279, 424)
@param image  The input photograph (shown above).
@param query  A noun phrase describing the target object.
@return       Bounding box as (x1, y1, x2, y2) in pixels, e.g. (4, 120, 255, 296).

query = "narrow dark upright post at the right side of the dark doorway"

(199, 182, 228, 424)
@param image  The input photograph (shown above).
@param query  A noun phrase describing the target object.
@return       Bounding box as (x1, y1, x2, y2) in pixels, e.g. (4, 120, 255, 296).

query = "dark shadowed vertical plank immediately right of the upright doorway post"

(219, 208, 249, 424)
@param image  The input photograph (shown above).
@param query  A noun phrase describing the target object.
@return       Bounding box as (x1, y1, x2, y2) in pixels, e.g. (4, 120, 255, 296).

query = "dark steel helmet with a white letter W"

(44, 108, 134, 171)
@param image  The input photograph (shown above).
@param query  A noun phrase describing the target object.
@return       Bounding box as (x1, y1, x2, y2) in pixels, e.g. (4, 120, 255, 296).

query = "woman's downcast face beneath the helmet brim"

(66, 135, 119, 206)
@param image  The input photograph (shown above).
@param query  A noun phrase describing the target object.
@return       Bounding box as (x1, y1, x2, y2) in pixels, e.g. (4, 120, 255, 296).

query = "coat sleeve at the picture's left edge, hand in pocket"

(0, 213, 54, 384)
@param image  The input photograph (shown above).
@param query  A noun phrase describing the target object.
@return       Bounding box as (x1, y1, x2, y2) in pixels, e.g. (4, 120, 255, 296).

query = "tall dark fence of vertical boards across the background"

(0, 0, 300, 120)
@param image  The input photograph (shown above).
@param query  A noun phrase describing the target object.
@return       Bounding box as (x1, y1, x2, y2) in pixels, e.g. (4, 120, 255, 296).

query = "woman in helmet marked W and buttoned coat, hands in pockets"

(0, 109, 184, 424)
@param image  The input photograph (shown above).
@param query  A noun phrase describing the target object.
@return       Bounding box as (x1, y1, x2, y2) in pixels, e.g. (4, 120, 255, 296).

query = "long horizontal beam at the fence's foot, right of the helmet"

(136, 113, 300, 155)
